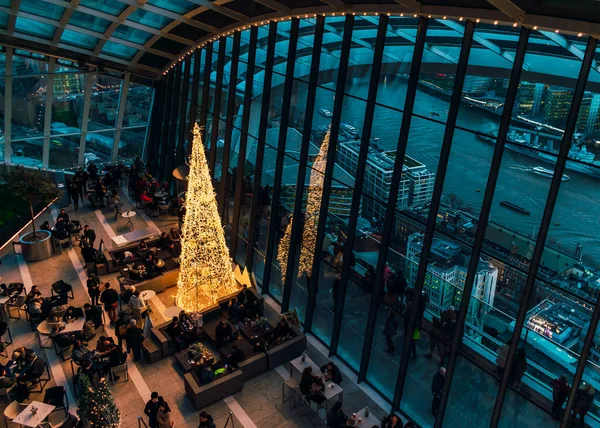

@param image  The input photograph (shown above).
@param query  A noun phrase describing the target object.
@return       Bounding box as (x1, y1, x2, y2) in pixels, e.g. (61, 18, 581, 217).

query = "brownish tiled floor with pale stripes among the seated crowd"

(0, 185, 389, 428)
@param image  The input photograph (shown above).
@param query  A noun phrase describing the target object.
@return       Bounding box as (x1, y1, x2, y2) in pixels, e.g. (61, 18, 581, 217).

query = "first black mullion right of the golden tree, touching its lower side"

(229, 26, 264, 262)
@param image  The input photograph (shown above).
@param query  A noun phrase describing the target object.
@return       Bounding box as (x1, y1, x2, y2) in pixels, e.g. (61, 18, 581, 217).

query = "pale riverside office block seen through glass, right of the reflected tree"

(336, 141, 435, 221)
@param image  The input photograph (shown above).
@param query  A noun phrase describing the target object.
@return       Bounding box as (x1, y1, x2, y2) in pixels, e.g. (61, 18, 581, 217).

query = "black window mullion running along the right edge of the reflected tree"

(304, 14, 354, 331)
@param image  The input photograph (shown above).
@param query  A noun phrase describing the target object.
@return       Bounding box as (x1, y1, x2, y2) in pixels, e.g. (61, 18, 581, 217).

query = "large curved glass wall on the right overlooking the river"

(149, 13, 600, 427)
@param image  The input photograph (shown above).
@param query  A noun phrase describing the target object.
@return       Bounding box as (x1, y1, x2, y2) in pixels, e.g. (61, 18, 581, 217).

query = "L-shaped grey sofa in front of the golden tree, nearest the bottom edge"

(184, 370, 244, 410)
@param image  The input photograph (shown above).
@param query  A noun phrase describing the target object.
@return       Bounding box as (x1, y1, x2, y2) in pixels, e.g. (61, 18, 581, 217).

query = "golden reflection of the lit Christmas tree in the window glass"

(277, 131, 330, 279)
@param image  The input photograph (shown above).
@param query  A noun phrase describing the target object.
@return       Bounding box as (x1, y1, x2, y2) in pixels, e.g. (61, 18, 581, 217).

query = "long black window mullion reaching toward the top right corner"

(490, 37, 597, 427)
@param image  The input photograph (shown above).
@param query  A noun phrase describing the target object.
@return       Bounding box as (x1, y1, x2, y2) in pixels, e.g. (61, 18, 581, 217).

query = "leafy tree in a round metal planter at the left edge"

(3, 166, 62, 261)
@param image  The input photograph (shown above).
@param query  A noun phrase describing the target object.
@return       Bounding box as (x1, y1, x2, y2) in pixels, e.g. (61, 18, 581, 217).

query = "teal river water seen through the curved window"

(299, 80, 600, 262)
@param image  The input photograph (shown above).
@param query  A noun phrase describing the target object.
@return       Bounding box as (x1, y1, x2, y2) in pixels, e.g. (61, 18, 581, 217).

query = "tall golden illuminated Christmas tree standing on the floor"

(177, 125, 238, 312)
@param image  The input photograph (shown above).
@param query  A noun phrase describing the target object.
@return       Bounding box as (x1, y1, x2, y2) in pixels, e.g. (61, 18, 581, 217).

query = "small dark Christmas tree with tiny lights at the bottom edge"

(77, 375, 121, 428)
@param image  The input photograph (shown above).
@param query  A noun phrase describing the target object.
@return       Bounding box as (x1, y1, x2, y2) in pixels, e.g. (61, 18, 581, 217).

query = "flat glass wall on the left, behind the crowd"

(0, 47, 154, 169)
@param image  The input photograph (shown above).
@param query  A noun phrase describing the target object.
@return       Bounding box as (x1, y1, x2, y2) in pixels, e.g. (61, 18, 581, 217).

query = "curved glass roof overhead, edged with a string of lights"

(0, 0, 600, 77)
